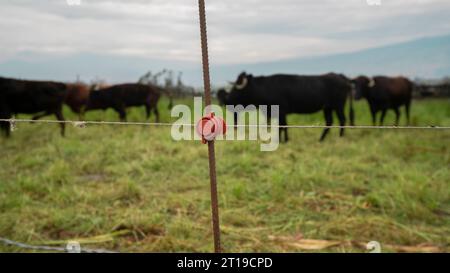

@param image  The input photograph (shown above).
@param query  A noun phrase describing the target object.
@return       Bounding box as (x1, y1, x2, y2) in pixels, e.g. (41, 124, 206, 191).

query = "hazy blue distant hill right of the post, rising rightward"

(208, 35, 450, 85)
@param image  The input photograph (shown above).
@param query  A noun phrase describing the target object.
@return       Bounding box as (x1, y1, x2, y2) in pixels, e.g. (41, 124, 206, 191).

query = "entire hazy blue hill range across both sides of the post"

(0, 35, 450, 87)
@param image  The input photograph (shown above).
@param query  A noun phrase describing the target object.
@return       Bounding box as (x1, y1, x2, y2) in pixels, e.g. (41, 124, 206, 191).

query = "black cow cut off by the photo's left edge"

(0, 77, 67, 136)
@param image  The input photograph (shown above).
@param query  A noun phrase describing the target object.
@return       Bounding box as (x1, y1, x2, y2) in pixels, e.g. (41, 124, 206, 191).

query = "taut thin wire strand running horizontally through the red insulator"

(0, 119, 450, 130)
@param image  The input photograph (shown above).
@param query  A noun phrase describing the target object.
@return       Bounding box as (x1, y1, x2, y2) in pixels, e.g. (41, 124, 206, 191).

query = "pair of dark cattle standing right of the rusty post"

(217, 72, 413, 142)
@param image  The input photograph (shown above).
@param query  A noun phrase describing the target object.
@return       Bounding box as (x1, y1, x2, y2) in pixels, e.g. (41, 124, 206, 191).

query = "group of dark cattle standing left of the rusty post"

(0, 78, 164, 136)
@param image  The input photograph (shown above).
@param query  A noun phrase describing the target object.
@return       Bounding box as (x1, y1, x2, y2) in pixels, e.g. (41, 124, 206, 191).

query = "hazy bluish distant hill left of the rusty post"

(0, 52, 202, 85)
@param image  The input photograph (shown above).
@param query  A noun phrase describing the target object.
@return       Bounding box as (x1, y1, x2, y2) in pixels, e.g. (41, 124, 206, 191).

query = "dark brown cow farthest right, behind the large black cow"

(352, 76, 413, 126)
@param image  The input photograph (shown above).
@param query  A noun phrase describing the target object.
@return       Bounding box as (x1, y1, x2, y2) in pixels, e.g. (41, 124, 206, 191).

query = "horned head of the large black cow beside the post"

(227, 72, 253, 106)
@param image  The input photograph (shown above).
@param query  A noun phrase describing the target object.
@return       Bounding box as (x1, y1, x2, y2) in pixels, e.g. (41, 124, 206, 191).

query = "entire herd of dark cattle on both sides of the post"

(0, 72, 413, 141)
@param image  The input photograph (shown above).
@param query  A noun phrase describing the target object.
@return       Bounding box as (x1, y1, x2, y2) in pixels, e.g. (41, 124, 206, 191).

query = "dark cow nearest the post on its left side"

(86, 84, 161, 122)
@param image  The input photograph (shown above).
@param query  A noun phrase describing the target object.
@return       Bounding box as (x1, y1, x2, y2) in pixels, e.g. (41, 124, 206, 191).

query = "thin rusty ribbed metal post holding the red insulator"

(198, 0, 221, 253)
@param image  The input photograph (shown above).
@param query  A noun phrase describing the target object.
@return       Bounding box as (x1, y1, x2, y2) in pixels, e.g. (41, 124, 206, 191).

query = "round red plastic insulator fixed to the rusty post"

(196, 113, 227, 144)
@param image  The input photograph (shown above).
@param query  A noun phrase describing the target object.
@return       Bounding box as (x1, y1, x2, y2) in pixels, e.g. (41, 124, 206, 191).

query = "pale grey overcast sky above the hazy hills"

(0, 0, 450, 84)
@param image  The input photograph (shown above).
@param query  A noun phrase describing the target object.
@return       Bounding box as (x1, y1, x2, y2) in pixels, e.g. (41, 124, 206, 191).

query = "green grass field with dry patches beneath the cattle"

(0, 97, 450, 252)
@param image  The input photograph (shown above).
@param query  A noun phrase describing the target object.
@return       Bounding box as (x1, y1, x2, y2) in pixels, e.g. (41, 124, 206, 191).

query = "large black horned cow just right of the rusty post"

(226, 72, 353, 142)
